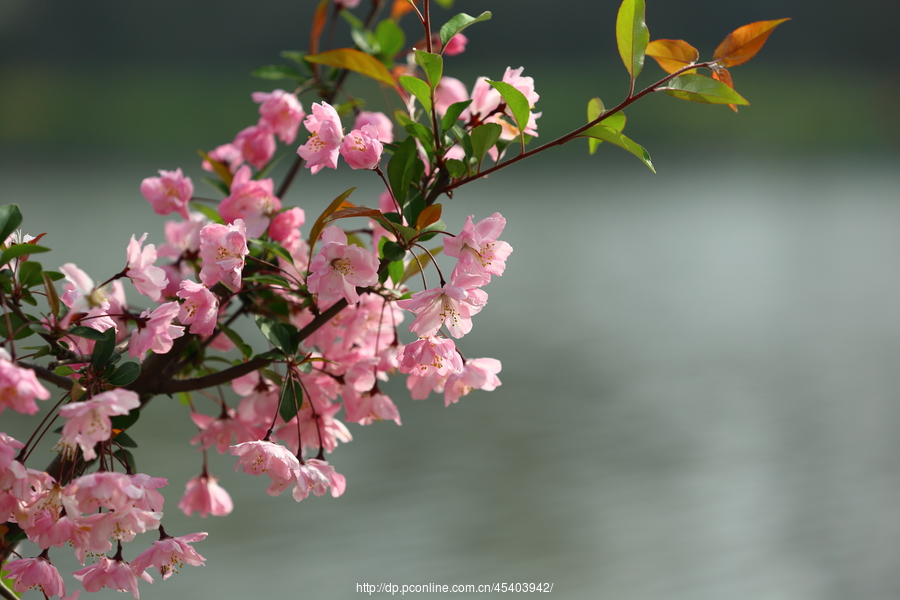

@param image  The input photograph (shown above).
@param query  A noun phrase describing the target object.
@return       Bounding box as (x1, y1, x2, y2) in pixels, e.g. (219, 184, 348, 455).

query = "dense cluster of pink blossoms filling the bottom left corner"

(0, 398, 206, 598)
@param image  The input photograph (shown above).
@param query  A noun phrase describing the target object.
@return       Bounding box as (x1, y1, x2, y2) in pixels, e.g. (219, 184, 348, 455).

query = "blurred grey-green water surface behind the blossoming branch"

(0, 157, 900, 600)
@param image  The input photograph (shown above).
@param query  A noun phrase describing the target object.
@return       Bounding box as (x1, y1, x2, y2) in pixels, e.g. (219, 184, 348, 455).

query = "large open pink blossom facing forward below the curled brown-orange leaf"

(306, 226, 378, 306)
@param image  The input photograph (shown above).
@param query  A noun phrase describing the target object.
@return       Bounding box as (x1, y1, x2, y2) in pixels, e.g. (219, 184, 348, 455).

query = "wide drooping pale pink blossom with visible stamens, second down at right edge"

(397, 284, 487, 339)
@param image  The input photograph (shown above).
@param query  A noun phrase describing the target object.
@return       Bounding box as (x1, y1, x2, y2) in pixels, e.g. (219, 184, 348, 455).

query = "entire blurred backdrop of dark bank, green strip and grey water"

(0, 0, 900, 600)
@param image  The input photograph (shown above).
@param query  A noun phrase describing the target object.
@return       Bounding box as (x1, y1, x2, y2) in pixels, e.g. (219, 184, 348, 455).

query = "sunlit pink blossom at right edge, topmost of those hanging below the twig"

(444, 213, 512, 285)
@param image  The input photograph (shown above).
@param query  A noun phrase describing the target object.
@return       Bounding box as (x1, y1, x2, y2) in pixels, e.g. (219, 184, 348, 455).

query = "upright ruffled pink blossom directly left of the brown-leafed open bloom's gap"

(200, 219, 250, 291)
